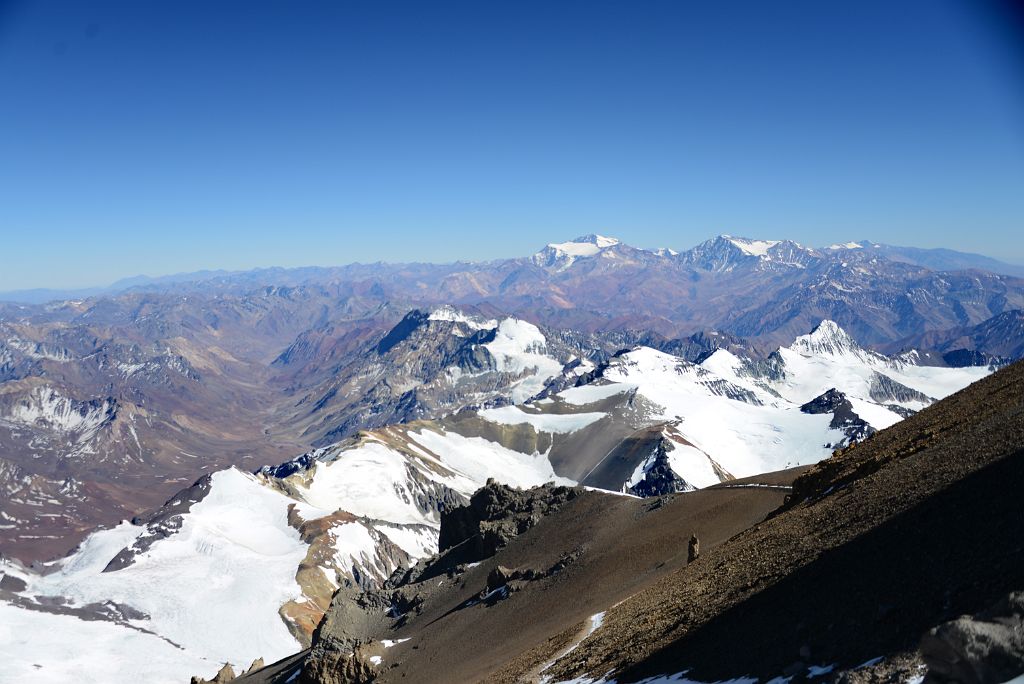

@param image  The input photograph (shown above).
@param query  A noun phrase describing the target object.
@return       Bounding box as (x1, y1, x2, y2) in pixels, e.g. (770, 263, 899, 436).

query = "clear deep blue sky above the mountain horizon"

(0, 0, 1024, 290)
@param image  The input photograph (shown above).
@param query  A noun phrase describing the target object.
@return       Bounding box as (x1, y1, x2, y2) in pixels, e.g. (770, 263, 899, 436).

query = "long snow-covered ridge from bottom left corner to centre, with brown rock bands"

(0, 419, 572, 682)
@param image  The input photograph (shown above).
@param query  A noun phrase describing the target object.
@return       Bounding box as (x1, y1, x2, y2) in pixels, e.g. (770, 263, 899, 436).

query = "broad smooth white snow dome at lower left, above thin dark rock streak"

(29, 468, 306, 681)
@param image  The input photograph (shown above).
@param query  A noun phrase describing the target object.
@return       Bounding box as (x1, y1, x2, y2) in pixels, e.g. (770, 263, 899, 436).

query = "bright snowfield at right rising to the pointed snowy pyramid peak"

(598, 320, 990, 486)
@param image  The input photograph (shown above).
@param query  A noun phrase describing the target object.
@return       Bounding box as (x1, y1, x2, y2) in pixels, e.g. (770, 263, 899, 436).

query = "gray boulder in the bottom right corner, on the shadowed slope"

(921, 592, 1024, 684)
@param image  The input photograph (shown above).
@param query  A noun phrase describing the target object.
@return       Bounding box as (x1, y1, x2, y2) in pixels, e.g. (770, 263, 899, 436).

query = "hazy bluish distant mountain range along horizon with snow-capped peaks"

(12, 236, 1024, 349)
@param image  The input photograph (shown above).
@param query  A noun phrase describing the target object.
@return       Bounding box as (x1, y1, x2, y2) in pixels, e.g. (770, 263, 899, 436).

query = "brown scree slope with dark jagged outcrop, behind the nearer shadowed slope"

(240, 472, 795, 684)
